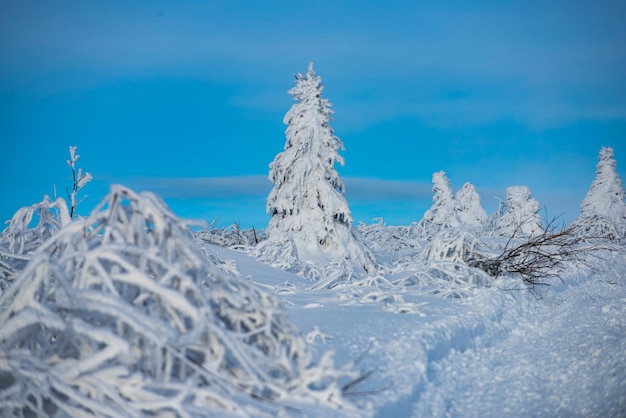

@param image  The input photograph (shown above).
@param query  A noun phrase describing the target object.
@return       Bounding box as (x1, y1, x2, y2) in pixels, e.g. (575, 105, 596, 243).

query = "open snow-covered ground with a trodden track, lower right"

(208, 246, 626, 417)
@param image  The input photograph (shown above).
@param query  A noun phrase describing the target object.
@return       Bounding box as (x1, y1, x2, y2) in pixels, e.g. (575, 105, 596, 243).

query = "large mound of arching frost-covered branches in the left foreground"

(0, 186, 350, 417)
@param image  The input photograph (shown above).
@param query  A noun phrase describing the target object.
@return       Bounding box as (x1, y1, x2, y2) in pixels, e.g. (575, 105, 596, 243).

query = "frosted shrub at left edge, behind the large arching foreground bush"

(0, 196, 71, 294)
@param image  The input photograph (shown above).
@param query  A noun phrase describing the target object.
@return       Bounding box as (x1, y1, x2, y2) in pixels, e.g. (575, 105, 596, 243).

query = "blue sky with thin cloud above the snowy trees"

(0, 0, 626, 227)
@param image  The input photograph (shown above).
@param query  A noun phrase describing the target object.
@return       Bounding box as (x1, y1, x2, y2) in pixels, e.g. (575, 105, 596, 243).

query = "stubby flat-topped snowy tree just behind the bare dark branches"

(496, 186, 543, 237)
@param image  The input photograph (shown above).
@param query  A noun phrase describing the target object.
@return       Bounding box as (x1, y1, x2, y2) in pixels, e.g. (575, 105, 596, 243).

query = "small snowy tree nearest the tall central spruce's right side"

(422, 171, 459, 232)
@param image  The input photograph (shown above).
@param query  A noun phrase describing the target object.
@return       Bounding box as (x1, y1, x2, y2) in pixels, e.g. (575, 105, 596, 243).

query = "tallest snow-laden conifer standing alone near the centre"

(258, 62, 375, 272)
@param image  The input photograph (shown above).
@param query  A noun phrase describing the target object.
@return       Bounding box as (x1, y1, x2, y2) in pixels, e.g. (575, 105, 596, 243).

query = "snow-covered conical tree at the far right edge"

(574, 147, 626, 240)
